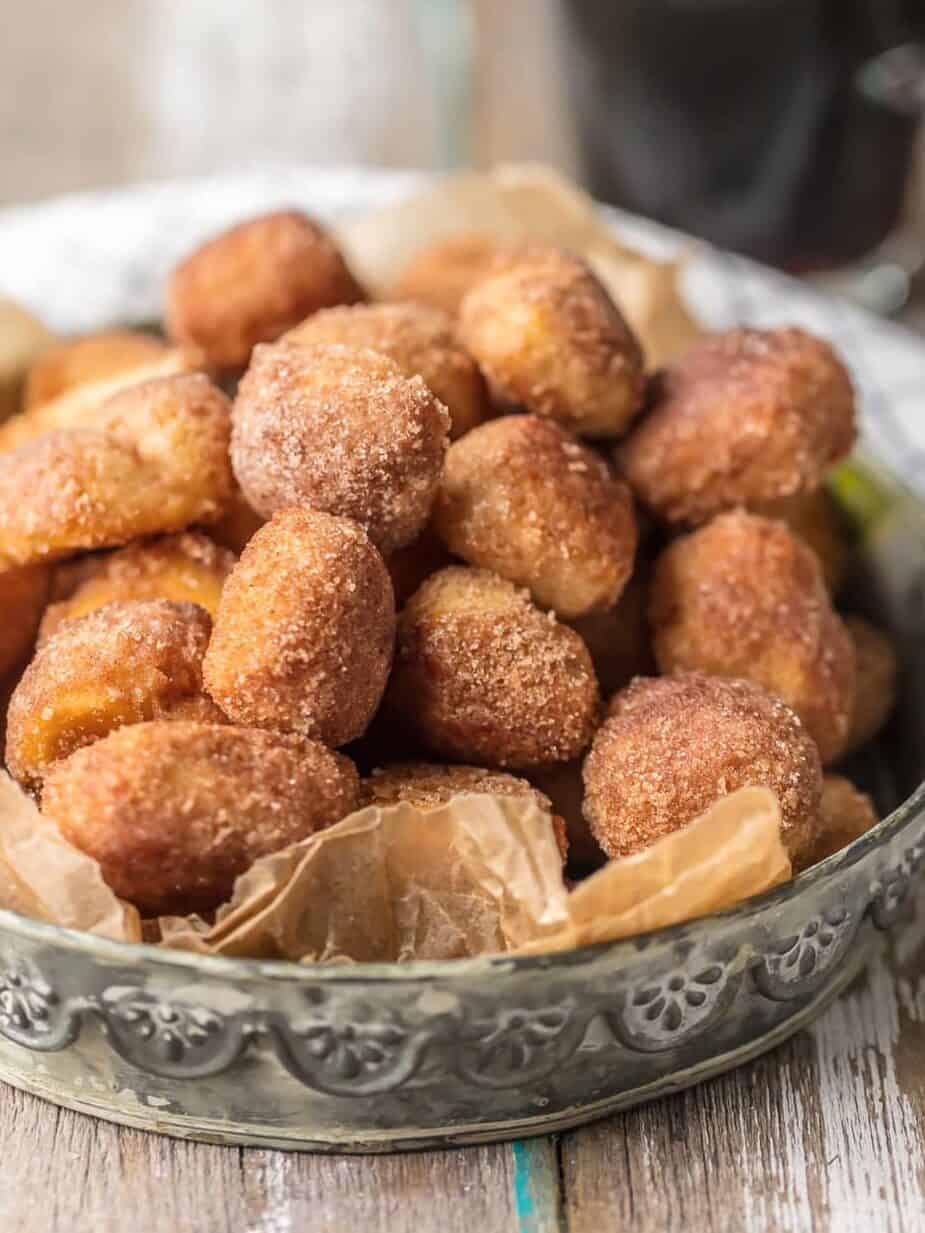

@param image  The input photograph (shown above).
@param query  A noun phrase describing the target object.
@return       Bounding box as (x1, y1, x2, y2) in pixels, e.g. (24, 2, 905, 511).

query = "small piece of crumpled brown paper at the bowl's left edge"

(0, 772, 142, 942)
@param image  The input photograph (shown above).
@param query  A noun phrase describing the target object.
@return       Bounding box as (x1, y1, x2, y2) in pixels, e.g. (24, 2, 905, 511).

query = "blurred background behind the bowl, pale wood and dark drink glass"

(0, 0, 925, 327)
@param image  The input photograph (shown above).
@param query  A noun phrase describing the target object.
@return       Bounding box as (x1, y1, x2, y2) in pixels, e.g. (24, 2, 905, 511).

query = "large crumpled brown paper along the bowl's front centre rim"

(160, 788, 791, 962)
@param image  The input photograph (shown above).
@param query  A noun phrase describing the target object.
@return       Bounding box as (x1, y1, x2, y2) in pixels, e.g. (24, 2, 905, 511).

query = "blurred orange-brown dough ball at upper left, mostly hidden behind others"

(23, 329, 170, 411)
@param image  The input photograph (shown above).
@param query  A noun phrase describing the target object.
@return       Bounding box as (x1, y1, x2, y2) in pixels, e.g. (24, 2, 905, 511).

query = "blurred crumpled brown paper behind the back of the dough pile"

(338, 163, 703, 367)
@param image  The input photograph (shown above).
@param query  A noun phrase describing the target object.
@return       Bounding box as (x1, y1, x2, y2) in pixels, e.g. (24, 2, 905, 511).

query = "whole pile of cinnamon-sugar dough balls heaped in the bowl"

(0, 212, 895, 916)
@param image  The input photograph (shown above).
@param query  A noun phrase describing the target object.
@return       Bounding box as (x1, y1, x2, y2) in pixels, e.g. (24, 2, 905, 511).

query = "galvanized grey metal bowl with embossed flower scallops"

(0, 173, 925, 1152)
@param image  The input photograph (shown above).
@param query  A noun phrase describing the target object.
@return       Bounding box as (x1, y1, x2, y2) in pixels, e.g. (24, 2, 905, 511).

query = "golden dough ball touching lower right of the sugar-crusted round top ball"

(433, 416, 638, 618)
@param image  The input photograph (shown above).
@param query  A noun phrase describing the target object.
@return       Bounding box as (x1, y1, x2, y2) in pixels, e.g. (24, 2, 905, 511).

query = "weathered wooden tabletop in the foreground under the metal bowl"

(0, 910, 925, 1233)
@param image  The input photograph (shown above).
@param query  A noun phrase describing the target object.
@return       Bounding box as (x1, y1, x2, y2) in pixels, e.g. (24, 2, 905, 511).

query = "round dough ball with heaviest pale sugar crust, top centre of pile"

(232, 343, 449, 554)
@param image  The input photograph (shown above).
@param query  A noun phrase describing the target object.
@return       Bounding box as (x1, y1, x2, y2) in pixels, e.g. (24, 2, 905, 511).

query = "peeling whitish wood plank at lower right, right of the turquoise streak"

(561, 922, 925, 1233)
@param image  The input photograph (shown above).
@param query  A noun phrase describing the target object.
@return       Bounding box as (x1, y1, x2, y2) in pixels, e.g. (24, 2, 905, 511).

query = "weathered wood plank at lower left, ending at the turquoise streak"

(0, 1088, 527, 1233)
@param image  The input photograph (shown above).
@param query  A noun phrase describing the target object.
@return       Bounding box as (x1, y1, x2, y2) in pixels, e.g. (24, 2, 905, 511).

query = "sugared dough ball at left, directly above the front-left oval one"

(6, 599, 211, 784)
